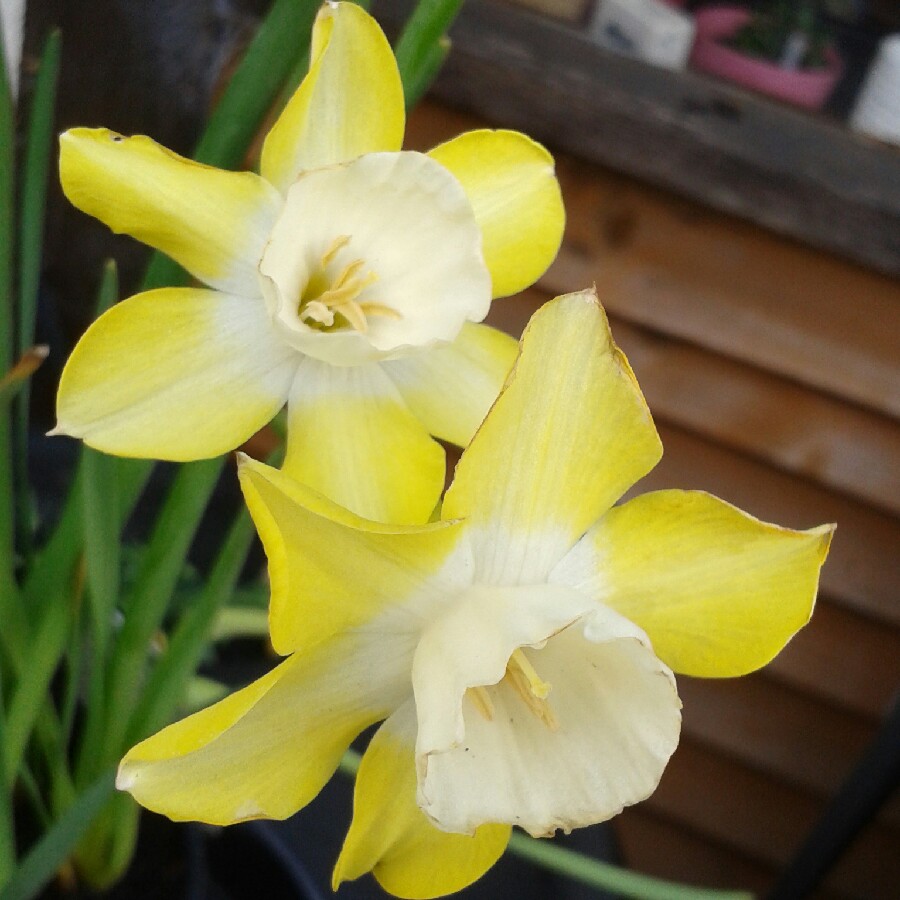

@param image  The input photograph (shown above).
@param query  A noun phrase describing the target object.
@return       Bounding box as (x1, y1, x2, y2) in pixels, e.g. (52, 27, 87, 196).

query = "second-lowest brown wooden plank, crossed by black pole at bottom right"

(645, 739, 900, 900)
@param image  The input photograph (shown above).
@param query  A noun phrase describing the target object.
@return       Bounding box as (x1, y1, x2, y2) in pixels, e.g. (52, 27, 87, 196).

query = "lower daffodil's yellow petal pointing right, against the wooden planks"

(552, 491, 834, 678)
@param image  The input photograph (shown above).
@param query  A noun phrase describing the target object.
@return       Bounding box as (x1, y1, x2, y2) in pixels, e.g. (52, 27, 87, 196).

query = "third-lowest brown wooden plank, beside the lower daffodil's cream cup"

(678, 673, 900, 828)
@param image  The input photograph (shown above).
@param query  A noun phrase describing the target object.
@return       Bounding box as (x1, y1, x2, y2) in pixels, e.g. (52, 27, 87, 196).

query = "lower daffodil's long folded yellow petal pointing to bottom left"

(116, 635, 409, 825)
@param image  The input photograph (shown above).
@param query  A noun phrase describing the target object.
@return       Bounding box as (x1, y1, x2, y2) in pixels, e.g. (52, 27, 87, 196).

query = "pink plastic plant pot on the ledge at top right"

(691, 6, 844, 109)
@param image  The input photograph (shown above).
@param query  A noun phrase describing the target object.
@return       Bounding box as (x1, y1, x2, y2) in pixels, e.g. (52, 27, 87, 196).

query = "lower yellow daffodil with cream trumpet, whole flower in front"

(118, 292, 832, 897)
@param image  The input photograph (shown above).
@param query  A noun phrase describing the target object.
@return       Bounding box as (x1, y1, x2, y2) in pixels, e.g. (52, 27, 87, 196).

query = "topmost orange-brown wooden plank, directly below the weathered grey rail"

(407, 104, 900, 415)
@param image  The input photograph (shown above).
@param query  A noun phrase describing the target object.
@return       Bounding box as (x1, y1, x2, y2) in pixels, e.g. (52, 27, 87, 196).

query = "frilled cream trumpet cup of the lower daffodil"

(414, 604, 681, 837)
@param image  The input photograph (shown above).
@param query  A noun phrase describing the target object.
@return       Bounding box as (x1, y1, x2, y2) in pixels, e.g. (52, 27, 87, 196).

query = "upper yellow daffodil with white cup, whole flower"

(56, 3, 564, 521)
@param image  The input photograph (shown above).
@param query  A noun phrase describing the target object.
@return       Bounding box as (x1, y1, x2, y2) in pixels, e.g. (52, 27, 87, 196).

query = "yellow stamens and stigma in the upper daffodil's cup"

(298, 234, 400, 334)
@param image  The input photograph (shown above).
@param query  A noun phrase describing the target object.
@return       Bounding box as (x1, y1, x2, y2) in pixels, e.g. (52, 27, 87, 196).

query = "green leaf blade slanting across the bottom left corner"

(0, 771, 115, 900)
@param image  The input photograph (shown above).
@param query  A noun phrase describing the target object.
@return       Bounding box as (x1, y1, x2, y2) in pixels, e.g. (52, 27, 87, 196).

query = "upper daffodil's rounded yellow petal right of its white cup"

(429, 130, 566, 297)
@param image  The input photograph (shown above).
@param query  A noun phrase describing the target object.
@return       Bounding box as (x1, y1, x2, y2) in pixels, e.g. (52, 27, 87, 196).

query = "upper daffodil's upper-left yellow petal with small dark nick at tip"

(59, 128, 282, 297)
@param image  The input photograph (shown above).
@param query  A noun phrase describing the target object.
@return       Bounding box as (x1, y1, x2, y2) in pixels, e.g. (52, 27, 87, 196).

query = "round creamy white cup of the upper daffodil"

(260, 153, 491, 366)
